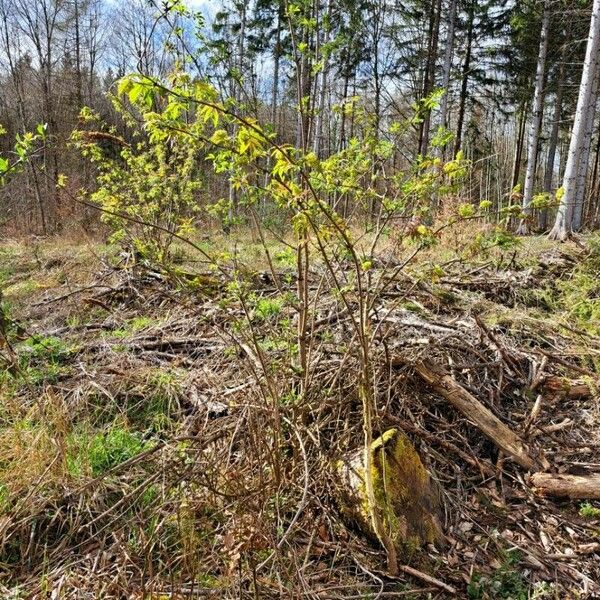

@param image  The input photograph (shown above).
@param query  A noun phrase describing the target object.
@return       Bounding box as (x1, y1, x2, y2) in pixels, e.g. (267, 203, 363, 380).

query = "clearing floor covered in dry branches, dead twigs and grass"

(0, 232, 600, 600)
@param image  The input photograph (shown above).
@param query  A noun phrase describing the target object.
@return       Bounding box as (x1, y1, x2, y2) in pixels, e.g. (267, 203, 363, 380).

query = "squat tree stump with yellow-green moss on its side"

(337, 429, 444, 557)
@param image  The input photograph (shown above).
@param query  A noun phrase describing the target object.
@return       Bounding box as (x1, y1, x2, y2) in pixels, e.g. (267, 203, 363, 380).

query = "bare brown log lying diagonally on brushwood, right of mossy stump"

(415, 361, 550, 471)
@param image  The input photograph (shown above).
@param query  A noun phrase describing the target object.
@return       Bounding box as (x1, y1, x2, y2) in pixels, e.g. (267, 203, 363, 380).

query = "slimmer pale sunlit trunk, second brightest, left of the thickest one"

(517, 0, 550, 235)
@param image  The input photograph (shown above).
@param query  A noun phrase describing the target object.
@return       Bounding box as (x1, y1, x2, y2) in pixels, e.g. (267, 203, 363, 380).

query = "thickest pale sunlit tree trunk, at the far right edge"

(549, 0, 600, 241)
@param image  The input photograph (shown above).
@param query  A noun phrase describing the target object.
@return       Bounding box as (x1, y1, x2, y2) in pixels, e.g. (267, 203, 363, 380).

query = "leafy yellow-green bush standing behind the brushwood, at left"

(73, 104, 202, 264)
